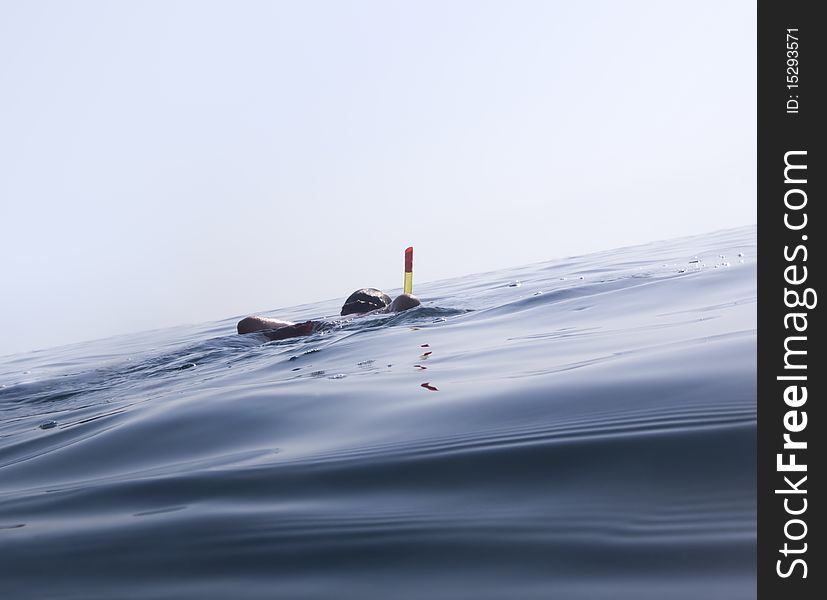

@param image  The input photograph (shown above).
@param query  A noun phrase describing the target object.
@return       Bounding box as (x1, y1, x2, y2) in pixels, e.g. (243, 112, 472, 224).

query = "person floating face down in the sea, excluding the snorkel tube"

(238, 288, 420, 340)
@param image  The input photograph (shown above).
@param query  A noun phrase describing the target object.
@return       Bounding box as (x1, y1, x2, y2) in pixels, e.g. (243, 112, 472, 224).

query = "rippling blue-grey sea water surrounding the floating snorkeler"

(0, 227, 756, 600)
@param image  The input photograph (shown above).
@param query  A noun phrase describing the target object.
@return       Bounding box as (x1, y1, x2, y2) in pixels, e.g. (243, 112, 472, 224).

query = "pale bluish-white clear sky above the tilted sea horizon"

(0, 0, 756, 354)
